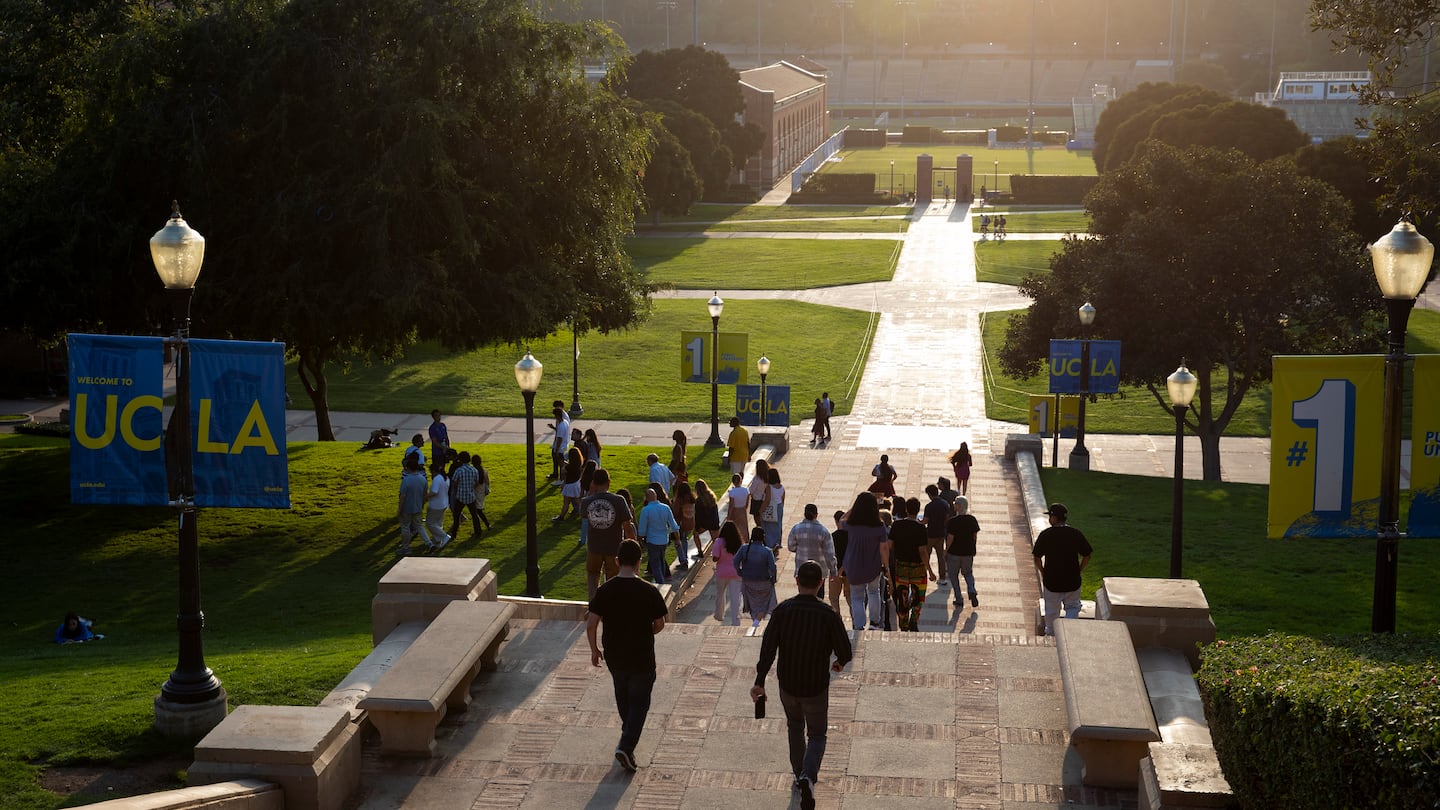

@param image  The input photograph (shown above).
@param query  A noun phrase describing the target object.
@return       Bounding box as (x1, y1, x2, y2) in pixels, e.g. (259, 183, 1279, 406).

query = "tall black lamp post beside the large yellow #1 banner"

(1369, 219, 1436, 633)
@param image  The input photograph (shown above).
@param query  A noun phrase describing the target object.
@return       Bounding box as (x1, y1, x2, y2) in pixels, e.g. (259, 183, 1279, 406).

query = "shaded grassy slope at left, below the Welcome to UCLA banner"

(0, 435, 691, 810)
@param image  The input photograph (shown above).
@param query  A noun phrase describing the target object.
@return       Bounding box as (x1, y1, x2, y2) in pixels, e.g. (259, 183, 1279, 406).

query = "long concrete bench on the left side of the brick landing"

(357, 600, 516, 757)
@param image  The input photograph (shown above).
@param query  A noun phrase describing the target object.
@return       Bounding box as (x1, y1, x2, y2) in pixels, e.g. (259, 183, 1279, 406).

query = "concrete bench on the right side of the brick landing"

(1056, 618, 1161, 790)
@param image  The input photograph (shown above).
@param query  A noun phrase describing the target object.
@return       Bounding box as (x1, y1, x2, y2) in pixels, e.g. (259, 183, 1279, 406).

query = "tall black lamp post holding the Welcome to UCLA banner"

(150, 203, 226, 736)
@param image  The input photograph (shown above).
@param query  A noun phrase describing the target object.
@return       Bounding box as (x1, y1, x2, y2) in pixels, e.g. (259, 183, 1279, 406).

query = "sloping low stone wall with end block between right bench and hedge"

(1136, 647, 1236, 810)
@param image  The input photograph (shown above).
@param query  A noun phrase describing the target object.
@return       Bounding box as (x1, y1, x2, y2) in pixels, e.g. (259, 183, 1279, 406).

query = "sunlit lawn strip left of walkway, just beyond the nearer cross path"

(626, 236, 900, 290)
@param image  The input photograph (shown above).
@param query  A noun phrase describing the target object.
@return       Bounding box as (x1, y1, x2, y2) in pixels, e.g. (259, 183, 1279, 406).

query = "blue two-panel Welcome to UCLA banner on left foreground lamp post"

(69, 334, 289, 509)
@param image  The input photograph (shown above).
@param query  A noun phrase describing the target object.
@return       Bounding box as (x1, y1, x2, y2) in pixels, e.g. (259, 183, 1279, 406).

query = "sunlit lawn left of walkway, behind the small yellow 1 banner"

(285, 298, 871, 423)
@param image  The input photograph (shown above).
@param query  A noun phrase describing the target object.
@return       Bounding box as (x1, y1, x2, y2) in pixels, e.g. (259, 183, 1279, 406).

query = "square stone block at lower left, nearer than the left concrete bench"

(187, 706, 360, 810)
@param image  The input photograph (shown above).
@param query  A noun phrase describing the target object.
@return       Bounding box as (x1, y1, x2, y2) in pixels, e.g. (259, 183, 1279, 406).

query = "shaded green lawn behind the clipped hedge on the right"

(1042, 467, 1440, 638)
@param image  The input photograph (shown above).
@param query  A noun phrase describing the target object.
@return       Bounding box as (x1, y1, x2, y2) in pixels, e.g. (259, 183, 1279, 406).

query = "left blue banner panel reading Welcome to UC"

(68, 334, 170, 506)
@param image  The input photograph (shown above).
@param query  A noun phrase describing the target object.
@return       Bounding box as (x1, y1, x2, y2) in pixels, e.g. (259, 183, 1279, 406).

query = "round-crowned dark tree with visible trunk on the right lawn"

(999, 143, 1378, 480)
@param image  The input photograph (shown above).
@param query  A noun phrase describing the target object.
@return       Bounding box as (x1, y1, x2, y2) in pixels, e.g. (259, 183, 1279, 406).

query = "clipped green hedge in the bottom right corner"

(1197, 634, 1440, 807)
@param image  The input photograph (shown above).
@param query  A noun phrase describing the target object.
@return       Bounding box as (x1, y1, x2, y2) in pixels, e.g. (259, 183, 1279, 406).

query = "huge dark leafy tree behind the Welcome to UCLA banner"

(0, 0, 651, 438)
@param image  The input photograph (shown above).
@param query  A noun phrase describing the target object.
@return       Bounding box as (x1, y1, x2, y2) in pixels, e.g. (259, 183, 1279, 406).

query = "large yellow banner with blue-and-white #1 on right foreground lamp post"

(1266, 355, 1385, 538)
